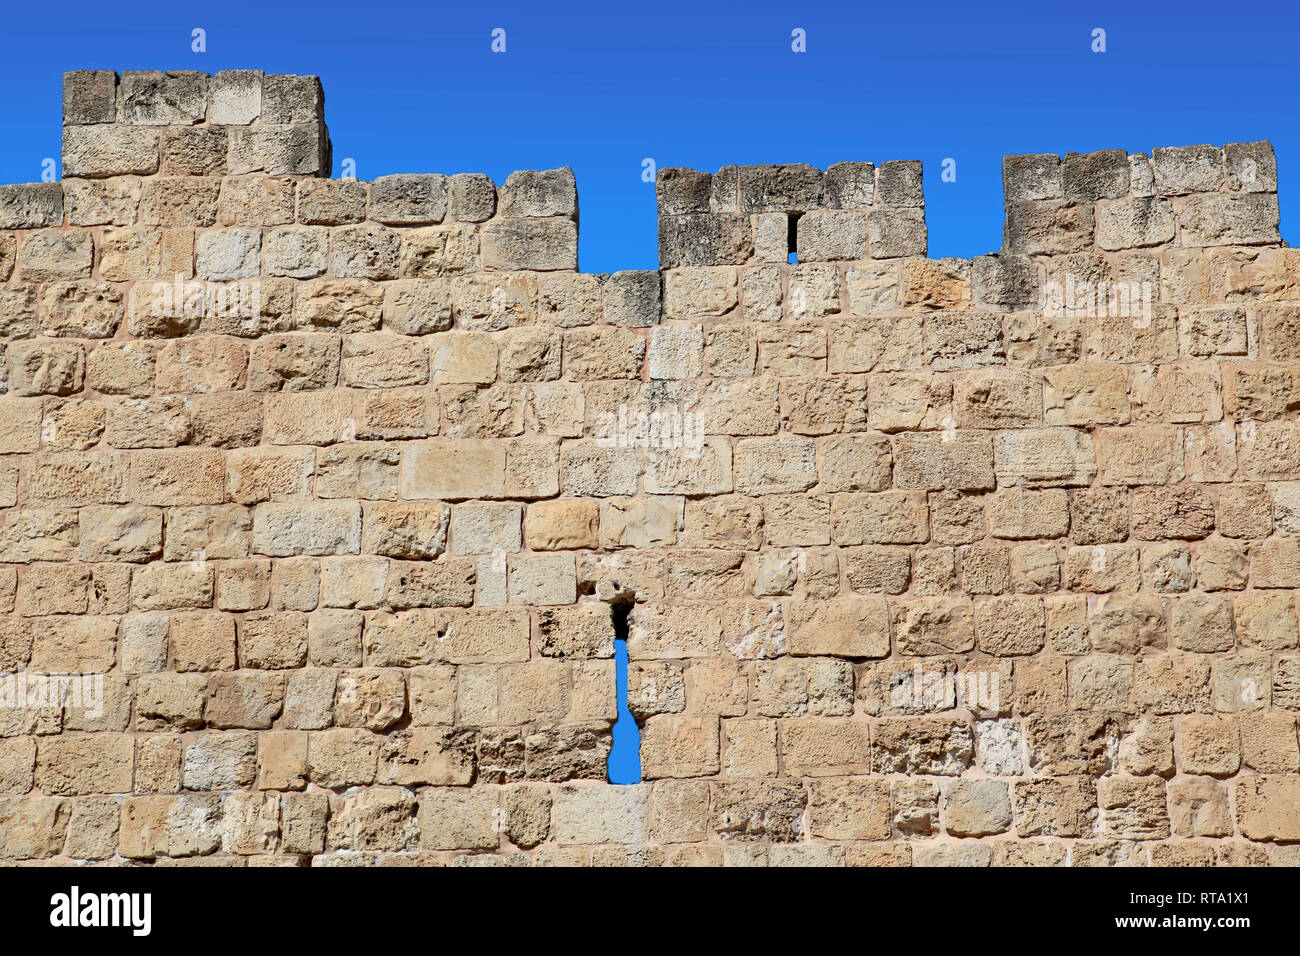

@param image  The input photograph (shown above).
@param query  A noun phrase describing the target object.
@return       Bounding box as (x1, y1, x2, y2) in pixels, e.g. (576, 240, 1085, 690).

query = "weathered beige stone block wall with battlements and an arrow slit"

(0, 72, 1300, 866)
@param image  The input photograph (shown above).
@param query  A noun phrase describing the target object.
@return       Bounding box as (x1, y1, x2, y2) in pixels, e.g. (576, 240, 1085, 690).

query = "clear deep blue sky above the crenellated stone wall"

(0, 0, 1300, 272)
